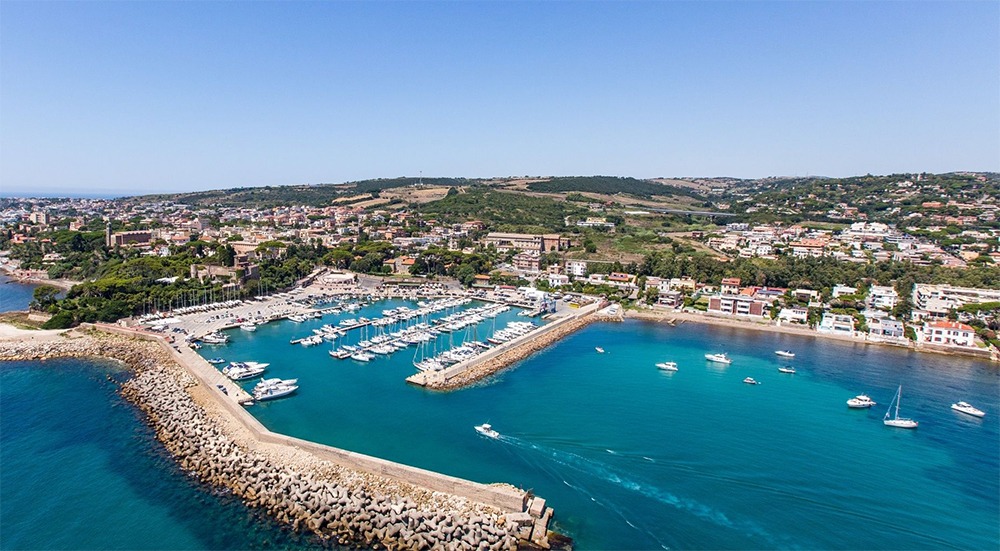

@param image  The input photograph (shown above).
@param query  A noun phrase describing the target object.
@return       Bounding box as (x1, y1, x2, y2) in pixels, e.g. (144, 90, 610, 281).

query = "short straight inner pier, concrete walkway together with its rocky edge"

(406, 308, 598, 390)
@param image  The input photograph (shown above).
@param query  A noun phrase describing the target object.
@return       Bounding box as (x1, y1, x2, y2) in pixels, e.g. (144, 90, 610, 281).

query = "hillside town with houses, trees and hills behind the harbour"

(0, 173, 1000, 358)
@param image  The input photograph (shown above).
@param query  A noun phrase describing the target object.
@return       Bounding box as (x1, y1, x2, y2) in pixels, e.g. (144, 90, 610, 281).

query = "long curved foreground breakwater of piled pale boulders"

(0, 331, 552, 551)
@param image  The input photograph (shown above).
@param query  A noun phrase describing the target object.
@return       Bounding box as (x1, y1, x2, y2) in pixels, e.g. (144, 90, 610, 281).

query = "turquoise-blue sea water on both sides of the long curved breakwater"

(0, 301, 1000, 549)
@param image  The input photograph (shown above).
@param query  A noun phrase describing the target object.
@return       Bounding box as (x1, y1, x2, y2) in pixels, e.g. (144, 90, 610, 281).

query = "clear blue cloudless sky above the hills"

(0, 0, 1000, 195)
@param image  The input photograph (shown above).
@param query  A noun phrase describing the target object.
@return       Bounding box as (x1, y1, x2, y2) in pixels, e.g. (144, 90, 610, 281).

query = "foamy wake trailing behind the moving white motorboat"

(499, 435, 788, 549)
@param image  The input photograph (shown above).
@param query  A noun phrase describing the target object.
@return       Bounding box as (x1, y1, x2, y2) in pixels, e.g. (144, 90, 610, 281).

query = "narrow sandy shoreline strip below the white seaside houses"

(625, 310, 998, 362)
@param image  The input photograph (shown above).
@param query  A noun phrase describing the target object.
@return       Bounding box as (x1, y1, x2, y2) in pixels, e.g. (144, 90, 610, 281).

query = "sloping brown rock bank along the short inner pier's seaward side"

(426, 314, 598, 390)
